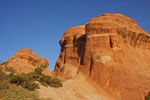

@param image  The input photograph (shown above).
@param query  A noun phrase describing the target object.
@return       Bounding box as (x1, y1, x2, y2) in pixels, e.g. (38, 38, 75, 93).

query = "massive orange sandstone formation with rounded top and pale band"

(54, 14, 150, 100)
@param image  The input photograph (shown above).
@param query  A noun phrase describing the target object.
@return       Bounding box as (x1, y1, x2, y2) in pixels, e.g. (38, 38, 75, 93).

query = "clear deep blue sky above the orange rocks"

(0, 0, 150, 70)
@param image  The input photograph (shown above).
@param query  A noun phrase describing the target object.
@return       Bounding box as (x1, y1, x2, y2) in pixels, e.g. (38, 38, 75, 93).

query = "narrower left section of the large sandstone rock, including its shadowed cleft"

(54, 26, 86, 80)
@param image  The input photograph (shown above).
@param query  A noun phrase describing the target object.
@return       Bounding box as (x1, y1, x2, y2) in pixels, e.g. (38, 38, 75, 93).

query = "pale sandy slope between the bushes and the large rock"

(37, 73, 108, 100)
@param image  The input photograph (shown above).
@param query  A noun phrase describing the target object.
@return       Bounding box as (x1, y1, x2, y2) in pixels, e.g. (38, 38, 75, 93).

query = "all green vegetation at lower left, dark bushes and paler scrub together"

(0, 66, 62, 100)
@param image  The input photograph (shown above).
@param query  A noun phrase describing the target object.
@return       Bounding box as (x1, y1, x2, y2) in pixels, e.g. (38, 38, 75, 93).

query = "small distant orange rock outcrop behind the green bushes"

(7, 49, 50, 73)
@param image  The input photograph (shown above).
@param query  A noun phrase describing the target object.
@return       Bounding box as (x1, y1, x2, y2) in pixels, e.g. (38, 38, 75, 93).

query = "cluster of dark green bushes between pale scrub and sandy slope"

(10, 65, 62, 91)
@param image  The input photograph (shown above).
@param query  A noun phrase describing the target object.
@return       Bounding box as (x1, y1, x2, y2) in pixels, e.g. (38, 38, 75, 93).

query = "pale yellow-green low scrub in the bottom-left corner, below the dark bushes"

(0, 70, 40, 100)
